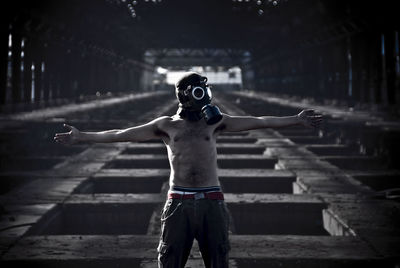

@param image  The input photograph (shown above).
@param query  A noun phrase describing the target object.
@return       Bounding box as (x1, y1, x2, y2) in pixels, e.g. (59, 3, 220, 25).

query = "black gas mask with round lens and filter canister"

(177, 77, 222, 125)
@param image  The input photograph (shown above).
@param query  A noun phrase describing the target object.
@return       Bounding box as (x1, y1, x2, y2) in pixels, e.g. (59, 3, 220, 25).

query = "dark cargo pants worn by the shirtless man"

(158, 199, 230, 268)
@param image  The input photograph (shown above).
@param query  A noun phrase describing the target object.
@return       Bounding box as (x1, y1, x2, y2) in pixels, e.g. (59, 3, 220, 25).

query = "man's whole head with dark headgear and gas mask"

(175, 72, 222, 125)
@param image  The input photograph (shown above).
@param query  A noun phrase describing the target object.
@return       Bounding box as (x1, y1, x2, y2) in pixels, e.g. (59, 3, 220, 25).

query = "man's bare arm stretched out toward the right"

(220, 110, 322, 131)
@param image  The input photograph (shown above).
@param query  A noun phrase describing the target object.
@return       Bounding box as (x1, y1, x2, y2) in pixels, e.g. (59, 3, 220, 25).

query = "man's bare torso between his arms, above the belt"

(158, 116, 223, 187)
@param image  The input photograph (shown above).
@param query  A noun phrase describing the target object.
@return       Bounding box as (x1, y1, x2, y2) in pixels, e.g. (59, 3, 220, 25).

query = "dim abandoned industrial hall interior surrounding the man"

(0, 0, 400, 268)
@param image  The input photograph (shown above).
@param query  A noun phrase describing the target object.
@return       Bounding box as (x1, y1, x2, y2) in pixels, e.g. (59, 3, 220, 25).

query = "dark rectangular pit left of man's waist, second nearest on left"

(74, 176, 168, 194)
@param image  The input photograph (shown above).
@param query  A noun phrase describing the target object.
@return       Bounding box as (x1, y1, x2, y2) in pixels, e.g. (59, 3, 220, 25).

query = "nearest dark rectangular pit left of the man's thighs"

(28, 203, 156, 235)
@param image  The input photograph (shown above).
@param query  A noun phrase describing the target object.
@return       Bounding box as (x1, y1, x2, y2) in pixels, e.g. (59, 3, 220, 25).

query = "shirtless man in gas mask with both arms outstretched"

(54, 72, 322, 268)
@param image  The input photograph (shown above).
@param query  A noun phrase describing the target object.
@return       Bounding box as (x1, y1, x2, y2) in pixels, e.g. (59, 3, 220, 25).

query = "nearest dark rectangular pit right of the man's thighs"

(225, 193, 329, 236)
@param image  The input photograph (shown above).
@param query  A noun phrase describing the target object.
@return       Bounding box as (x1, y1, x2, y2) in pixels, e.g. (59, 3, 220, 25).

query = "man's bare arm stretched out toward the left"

(54, 116, 169, 144)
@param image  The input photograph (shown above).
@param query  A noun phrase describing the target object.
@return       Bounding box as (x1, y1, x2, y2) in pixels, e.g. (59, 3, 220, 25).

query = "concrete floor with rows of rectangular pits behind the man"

(0, 92, 400, 268)
